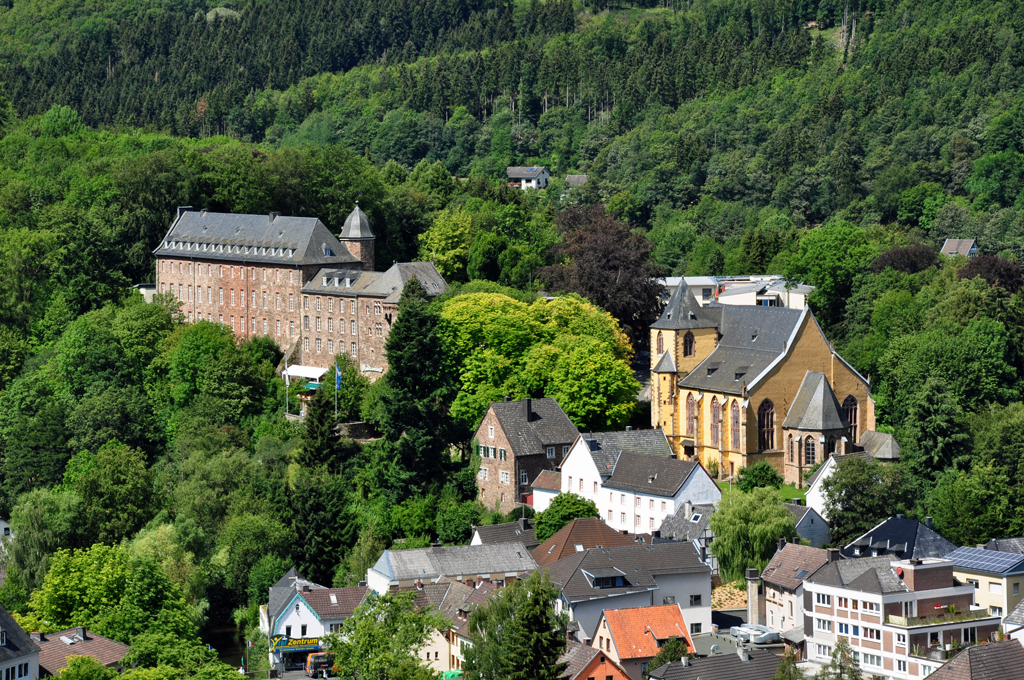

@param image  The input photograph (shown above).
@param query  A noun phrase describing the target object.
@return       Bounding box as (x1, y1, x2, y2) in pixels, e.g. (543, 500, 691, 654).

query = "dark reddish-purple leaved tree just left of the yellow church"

(538, 205, 662, 342)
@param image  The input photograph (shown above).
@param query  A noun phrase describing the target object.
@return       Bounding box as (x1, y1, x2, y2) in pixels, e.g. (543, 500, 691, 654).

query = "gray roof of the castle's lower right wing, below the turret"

(302, 262, 447, 303)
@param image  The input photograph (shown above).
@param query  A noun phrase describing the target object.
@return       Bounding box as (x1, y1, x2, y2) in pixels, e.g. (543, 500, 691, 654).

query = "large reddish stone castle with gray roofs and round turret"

(154, 206, 447, 378)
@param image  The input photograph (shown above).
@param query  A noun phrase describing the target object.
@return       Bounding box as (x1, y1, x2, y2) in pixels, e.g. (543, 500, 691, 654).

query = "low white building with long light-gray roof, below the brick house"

(367, 542, 537, 595)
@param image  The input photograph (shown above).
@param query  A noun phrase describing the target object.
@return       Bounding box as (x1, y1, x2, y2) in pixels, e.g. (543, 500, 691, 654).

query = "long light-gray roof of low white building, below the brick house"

(373, 542, 537, 581)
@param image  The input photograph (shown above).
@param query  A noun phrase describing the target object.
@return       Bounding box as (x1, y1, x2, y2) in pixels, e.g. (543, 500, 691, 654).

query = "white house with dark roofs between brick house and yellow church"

(561, 429, 722, 534)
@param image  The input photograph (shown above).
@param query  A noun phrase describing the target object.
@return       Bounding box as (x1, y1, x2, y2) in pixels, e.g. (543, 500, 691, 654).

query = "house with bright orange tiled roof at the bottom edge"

(591, 604, 694, 680)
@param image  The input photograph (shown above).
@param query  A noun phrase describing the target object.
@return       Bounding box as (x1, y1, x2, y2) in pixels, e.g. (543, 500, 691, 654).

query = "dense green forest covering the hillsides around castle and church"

(0, 0, 1024, 678)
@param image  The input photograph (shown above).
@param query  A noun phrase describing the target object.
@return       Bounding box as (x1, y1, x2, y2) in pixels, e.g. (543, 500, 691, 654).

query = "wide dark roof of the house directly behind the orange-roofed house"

(542, 542, 711, 602)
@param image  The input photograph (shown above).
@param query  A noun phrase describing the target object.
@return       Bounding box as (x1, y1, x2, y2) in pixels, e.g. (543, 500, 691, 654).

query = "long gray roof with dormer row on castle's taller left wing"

(153, 210, 359, 266)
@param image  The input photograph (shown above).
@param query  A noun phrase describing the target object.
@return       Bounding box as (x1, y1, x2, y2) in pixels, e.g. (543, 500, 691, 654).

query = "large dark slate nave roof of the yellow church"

(679, 305, 804, 394)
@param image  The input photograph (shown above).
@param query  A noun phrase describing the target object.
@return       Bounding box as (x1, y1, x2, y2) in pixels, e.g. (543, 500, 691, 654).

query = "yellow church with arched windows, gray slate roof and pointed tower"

(650, 282, 874, 475)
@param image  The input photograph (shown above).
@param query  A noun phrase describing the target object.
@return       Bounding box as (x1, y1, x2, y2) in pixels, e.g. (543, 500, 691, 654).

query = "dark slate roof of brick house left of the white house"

(490, 397, 580, 456)
